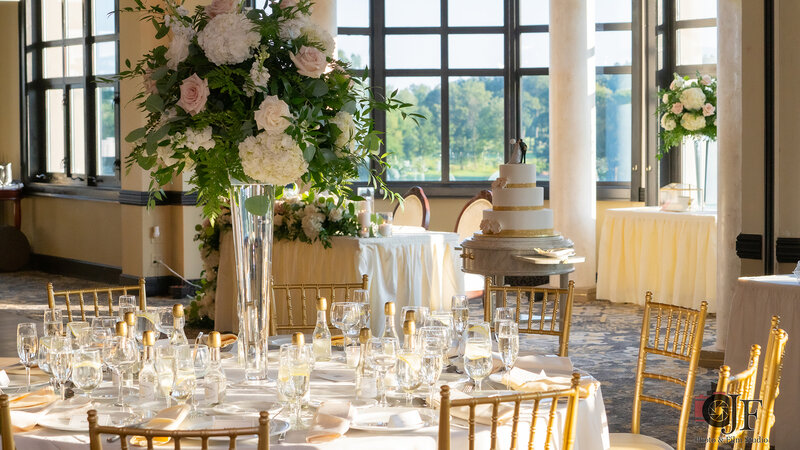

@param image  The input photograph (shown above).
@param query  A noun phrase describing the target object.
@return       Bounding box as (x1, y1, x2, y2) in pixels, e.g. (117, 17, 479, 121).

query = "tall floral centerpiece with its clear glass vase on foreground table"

(120, 0, 414, 380)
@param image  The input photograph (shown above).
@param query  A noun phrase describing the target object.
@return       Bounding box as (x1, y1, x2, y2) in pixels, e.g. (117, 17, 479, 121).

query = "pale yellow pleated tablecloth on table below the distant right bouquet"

(597, 207, 717, 313)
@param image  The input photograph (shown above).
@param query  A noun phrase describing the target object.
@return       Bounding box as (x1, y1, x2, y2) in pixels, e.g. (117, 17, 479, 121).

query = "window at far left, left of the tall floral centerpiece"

(21, 0, 120, 187)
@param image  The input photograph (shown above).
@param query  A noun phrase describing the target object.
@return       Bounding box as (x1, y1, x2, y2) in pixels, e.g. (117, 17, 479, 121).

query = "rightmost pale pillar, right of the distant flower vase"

(714, 0, 756, 350)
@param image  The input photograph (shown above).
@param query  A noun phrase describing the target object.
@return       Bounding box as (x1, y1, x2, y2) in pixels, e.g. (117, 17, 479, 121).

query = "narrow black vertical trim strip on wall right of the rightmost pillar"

(764, 0, 775, 275)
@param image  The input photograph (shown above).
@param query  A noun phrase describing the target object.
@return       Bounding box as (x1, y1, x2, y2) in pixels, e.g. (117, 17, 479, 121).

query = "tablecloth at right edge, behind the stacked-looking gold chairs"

(725, 275, 800, 448)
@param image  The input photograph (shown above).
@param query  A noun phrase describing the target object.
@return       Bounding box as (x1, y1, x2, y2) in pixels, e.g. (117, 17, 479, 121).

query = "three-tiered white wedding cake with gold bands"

(481, 164, 556, 237)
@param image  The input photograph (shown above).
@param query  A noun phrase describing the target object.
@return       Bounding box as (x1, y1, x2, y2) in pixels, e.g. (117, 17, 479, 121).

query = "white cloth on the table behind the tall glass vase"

(215, 227, 464, 330)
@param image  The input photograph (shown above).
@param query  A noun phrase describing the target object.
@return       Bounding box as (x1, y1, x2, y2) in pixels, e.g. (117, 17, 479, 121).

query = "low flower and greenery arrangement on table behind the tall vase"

(273, 193, 359, 248)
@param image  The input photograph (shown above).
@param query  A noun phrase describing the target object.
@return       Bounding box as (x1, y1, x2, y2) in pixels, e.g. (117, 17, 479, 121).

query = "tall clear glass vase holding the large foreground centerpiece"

(230, 182, 275, 382)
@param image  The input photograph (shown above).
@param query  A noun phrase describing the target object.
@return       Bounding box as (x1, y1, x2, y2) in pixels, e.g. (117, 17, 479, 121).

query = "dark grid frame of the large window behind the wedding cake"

(338, 0, 642, 200)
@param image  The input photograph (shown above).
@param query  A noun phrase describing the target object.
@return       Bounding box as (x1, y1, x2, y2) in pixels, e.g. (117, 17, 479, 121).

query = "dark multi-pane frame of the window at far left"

(19, 0, 121, 193)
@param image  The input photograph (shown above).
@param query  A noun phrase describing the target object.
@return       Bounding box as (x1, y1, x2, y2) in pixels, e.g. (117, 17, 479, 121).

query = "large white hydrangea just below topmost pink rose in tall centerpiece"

(197, 13, 261, 66)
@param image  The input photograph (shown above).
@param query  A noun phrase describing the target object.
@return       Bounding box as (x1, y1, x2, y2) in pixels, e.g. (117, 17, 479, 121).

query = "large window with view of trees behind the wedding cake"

(337, 0, 634, 198)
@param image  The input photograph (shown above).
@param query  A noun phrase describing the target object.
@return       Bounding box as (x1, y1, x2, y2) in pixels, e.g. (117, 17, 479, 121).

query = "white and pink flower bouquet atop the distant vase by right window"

(656, 72, 717, 159)
